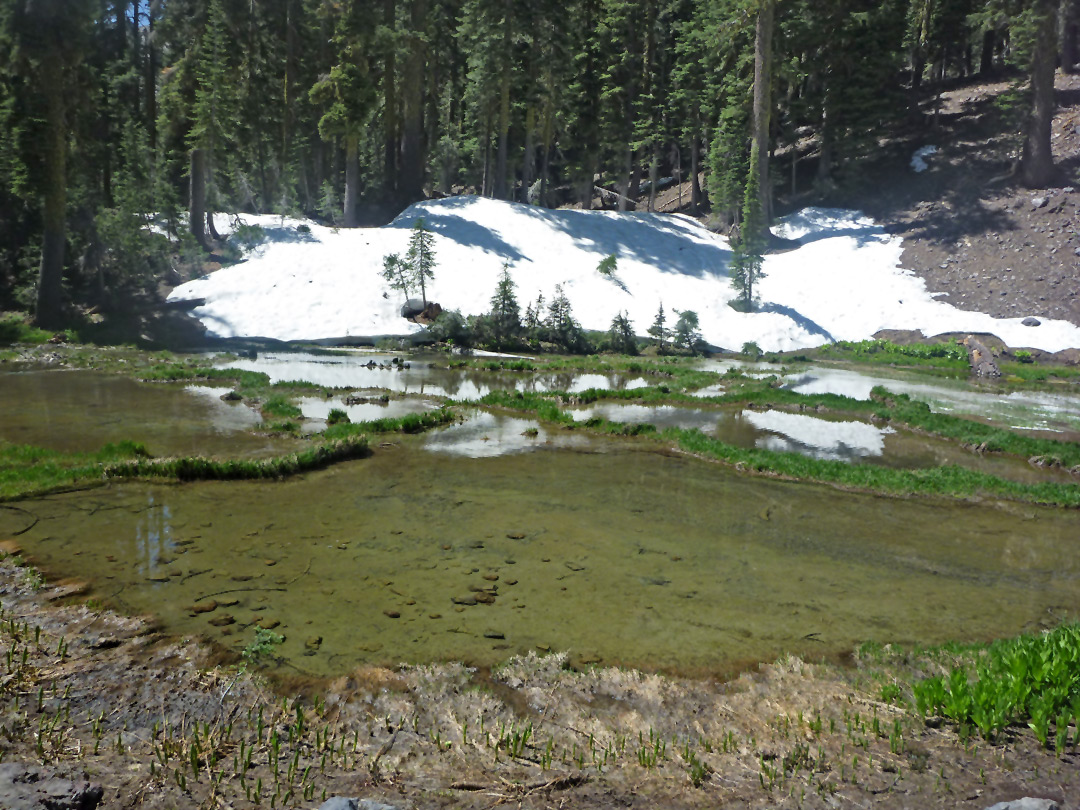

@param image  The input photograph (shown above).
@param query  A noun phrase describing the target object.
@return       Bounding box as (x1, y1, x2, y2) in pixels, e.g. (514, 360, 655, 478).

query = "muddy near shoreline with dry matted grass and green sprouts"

(0, 557, 1080, 808)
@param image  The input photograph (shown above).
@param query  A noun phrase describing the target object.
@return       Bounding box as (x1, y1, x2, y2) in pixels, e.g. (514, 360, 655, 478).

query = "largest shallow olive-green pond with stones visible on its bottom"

(0, 444, 1080, 675)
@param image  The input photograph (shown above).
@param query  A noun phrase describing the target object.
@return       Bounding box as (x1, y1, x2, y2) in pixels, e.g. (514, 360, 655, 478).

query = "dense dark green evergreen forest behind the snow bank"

(0, 0, 1080, 328)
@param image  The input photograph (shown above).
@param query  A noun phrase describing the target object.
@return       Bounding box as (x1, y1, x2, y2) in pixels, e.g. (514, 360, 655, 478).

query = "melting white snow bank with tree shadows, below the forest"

(170, 197, 1080, 351)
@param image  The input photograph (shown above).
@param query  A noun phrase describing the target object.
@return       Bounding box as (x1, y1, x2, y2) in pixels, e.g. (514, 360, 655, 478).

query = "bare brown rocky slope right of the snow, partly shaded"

(642, 72, 1080, 337)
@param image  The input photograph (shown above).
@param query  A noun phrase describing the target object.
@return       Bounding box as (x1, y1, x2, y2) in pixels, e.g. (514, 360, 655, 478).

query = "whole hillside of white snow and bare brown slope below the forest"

(162, 75, 1080, 352)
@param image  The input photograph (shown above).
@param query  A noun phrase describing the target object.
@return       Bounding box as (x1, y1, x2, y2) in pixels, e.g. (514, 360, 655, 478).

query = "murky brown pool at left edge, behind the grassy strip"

(0, 370, 287, 458)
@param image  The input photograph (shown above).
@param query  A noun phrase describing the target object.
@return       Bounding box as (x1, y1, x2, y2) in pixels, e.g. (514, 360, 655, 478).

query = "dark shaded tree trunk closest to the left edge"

(35, 54, 67, 329)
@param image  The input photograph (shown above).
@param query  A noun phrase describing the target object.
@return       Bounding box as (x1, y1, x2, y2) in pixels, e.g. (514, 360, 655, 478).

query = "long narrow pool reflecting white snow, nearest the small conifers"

(214, 352, 649, 400)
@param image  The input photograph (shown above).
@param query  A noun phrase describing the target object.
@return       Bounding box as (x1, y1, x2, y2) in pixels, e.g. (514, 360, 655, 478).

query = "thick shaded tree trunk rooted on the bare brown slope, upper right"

(1020, 0, 1057, 188)
